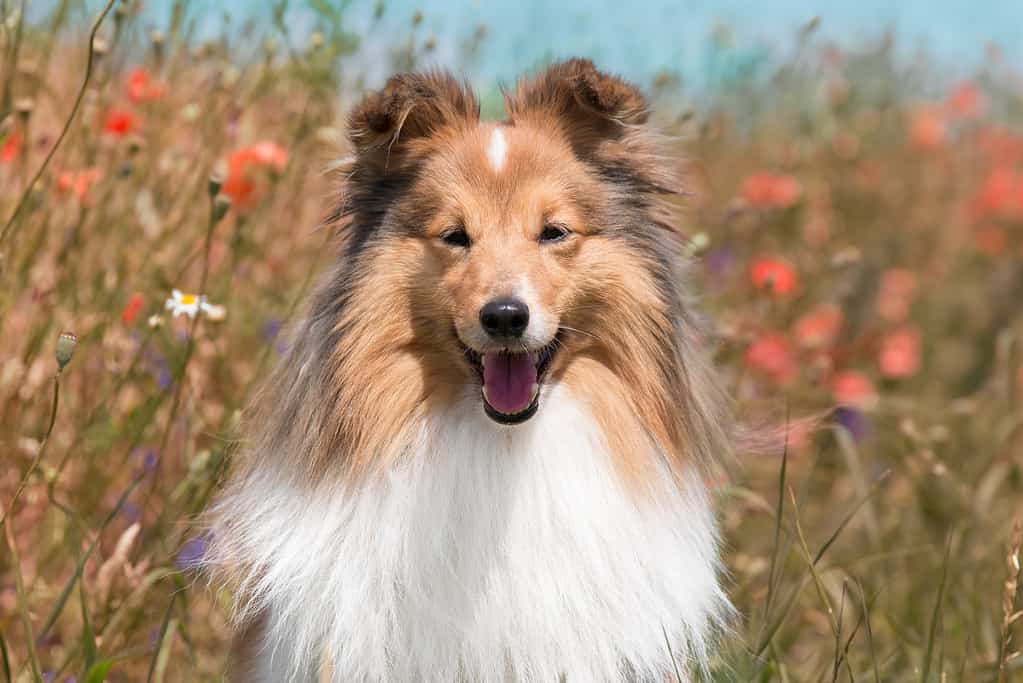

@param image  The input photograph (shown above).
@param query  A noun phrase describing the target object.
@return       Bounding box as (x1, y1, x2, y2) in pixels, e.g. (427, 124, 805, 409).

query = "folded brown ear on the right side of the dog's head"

(504, 59, 650, 152)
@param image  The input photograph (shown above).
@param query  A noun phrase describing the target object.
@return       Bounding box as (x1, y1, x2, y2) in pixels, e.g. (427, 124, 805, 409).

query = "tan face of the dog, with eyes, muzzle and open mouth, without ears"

(400, 124, 602, 424)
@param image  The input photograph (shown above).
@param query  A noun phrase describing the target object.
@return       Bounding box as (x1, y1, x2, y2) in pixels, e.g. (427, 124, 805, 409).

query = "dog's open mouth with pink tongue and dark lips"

(463, 338, 558, 424)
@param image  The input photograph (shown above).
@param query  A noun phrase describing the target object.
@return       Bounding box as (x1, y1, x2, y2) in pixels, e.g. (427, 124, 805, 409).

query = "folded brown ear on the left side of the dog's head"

(348, 71, 480, 174)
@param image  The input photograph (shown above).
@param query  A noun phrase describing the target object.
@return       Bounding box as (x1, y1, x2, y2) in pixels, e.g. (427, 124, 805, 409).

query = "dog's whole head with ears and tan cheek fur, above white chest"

(280, 59, 728, 480)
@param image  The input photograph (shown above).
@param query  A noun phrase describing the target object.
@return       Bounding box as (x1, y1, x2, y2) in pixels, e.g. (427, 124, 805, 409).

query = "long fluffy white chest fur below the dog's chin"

(213, 388, 730, 683)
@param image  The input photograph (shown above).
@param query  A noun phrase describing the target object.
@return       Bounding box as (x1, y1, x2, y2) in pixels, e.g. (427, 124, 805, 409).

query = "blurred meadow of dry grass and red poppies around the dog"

(0, 1, 1023, 683)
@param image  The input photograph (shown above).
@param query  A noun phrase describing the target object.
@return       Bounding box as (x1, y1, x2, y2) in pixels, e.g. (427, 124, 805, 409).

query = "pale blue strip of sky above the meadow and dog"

(39, 0, 1023, 86)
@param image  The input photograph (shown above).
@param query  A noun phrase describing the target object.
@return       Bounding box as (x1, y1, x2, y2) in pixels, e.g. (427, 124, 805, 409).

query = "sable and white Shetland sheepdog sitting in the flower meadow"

(210, 59, 731, 683)
